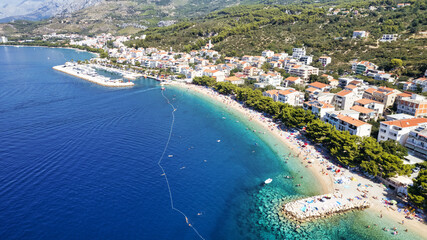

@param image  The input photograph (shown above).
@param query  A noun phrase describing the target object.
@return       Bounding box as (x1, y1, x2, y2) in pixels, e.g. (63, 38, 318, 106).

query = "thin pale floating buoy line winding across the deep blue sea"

(157, 91, 205, 240)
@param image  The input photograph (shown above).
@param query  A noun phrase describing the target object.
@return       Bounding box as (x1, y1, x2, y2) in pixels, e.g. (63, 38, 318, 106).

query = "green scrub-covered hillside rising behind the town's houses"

(129, 0, 427, 76)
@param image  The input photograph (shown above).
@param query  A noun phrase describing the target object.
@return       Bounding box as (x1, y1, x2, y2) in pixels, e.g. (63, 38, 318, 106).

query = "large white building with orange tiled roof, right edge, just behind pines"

(378, 118, 427, 145)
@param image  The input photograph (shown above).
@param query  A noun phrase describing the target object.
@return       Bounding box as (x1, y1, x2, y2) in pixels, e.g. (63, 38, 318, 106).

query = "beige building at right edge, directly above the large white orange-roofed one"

(397, 94, 427, 117)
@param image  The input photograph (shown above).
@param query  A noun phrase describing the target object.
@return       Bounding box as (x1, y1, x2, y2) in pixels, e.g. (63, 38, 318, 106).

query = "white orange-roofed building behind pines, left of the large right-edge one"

(323, 112, 372, 137)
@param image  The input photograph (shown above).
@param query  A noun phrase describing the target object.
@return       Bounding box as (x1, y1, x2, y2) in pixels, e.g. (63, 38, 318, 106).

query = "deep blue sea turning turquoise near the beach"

(0, 47, 420, 240)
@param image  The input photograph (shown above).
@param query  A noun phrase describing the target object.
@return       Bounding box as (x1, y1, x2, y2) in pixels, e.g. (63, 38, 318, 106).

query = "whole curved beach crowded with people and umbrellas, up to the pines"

(171, 82, 427, 236)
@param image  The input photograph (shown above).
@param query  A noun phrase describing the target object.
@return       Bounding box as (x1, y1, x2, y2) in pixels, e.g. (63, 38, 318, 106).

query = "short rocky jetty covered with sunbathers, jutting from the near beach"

(283, 193, 371, 222)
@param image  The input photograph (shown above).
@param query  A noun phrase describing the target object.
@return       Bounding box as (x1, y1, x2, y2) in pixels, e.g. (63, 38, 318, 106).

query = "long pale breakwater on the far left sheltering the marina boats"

(53, 62, 135, 87)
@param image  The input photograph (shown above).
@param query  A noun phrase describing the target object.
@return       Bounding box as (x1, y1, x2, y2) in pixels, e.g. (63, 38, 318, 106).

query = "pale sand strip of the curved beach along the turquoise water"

(173, 82, 427, 236)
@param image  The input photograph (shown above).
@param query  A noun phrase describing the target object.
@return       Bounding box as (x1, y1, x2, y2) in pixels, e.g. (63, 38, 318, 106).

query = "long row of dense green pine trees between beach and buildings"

(193, 76, 411, 178)
